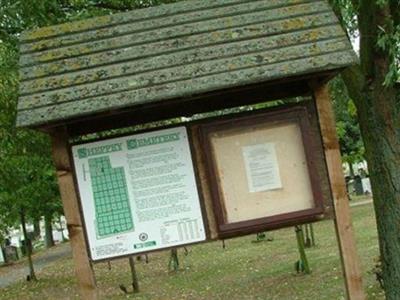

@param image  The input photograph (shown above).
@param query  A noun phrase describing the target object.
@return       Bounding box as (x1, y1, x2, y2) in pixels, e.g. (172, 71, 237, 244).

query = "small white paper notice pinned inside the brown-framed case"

(242, 143, 282, 193)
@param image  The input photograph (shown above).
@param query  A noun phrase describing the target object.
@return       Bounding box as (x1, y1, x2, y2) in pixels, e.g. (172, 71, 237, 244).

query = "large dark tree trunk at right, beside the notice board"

(343, 0, 400, 300)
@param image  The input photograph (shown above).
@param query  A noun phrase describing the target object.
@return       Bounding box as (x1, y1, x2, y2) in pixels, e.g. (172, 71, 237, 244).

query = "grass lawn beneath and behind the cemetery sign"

(0, 204, 384, 300)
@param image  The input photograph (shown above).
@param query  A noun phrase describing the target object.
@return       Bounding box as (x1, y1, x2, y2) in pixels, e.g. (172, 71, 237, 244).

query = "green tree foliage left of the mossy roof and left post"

(0, 1, 65, 237)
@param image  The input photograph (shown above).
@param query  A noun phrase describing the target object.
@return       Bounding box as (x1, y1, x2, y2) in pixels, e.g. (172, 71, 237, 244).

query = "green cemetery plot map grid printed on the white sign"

(88, 156, 134, 238)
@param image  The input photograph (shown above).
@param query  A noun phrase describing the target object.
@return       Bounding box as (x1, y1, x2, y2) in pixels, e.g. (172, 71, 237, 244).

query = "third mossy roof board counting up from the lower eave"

(20, 25, 347, 94)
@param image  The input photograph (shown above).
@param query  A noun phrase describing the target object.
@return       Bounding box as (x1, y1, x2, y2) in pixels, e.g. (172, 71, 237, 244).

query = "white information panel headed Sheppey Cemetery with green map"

(72, 127, 206, 261)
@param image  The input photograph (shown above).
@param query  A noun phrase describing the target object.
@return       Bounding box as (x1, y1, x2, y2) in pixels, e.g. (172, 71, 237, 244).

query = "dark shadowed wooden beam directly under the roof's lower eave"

(64, 78, 310, 136)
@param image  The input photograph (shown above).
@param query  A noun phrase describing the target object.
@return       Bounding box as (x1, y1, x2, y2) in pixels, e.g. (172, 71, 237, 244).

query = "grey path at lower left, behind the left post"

(0, 243, 72, 289)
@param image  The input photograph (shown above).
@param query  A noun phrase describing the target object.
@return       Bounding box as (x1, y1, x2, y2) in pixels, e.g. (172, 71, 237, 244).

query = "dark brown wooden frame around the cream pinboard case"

(200, 105, 324, 238)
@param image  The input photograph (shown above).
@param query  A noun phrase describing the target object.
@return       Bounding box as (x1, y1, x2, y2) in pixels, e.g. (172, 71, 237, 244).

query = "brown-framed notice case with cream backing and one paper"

(200, 106, 324, 237)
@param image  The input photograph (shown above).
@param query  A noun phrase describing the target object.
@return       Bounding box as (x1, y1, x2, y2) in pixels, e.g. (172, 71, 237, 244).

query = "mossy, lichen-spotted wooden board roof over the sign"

(17, 0, 357, 127)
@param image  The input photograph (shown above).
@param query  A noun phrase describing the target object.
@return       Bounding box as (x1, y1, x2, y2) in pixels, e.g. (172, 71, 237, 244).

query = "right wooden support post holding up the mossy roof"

(312, 84, 365, 300)
